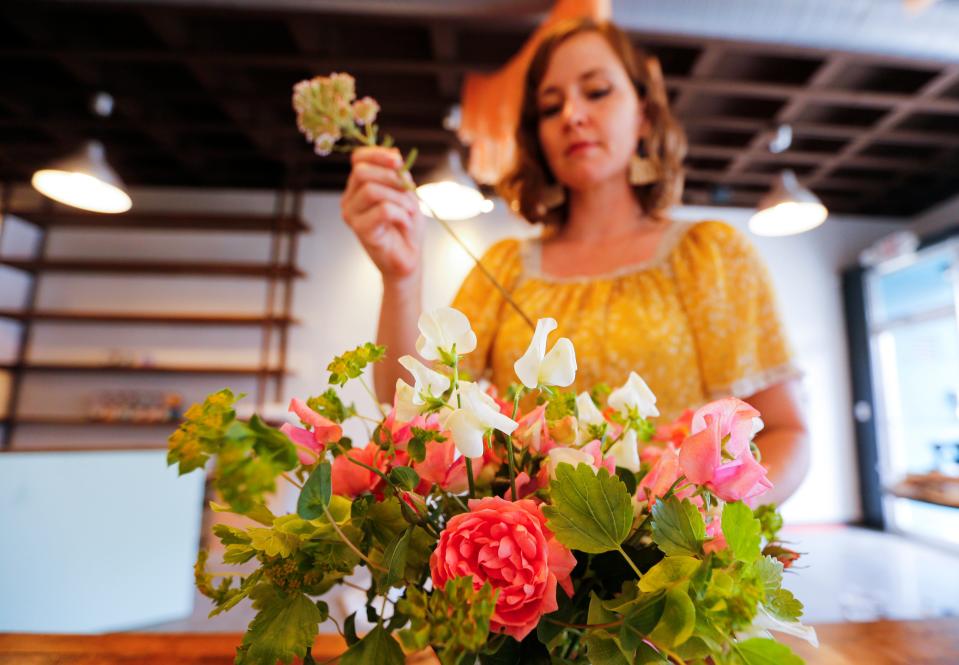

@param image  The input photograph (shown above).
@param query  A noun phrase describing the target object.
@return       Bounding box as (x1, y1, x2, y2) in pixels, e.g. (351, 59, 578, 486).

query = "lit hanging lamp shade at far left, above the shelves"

(30, 141, 132, 213)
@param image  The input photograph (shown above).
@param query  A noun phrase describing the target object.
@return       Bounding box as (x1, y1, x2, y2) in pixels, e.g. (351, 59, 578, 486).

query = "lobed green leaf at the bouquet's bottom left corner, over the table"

(235, 584, 320, 665)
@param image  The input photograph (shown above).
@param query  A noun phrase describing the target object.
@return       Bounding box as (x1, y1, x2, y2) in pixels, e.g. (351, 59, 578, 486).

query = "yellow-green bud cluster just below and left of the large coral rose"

(397, 577, 497, 665)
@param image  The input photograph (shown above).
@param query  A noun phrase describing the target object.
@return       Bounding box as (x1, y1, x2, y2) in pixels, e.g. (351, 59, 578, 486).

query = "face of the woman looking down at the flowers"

(536, 32, 642, 189)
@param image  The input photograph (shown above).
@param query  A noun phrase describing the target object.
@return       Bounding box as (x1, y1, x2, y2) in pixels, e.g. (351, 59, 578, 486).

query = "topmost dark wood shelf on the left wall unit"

(8, 210, 309, 233)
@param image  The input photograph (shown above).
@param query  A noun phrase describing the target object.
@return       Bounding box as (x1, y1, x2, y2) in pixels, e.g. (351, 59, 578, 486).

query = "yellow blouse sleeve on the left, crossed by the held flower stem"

(452, 238, 522, 379)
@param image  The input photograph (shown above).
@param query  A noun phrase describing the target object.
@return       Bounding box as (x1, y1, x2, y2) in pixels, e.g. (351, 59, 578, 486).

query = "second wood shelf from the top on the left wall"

(0, 258, 304, 278)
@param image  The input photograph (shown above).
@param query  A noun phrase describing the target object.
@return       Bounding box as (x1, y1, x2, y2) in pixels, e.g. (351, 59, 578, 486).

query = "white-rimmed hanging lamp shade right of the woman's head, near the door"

(749, 171, 829, 236)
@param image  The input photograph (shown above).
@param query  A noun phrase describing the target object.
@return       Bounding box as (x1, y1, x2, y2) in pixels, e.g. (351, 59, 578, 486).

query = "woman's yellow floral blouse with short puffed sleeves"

(453, 221, 798, 422)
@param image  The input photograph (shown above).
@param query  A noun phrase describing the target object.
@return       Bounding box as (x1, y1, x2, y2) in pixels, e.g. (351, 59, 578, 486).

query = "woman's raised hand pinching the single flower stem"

(340, 147, 424, 283)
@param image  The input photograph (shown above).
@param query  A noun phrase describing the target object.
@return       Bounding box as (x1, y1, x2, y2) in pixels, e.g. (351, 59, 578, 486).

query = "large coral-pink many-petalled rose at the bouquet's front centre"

(430, 497, 576, 640)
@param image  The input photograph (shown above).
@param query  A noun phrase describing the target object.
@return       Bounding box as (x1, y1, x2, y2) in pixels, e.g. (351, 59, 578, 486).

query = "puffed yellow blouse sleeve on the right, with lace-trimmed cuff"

(675, 222, 800, 399)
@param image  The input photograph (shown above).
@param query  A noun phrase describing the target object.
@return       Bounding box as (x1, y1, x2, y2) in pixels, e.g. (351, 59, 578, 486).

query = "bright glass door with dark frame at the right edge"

(865, 241, 959, 547)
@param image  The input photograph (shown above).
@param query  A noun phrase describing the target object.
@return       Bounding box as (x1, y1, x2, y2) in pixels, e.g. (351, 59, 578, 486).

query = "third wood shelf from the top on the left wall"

(0, 309, 297, 327)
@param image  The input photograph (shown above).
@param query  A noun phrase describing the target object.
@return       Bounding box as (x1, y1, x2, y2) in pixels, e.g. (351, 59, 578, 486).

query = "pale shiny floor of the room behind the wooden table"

(141, 526, 959, 632)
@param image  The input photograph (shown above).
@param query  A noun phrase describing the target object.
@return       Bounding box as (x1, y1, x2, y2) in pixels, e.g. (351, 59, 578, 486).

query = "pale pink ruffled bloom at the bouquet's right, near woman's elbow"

(679, 397, 772, 501)
